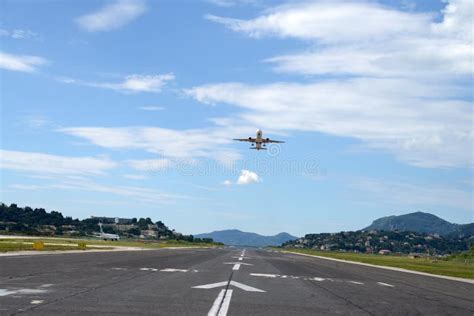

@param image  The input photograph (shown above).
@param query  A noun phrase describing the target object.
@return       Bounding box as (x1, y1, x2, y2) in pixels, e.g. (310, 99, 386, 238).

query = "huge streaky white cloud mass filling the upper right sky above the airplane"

(193, 0, 474, 167)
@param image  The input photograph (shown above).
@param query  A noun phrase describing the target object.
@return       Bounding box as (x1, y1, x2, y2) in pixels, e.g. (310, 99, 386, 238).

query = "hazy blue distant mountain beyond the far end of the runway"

(194, 229, 298, 247)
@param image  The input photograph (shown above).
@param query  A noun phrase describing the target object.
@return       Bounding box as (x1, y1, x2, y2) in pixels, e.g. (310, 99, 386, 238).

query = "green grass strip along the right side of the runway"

(284, 249, 474, 279)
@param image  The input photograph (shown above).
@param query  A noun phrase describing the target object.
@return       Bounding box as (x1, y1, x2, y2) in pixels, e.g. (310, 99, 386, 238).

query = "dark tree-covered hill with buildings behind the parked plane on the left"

(0, 203, 212, 242)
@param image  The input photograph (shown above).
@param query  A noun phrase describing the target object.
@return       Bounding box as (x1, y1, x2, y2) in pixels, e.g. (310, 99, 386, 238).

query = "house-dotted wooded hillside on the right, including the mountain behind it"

(283, 212, 474, 254)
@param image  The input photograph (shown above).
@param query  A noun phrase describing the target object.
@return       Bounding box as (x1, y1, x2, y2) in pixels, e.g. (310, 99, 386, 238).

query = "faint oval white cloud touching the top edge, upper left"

(76, 0, 146, 32)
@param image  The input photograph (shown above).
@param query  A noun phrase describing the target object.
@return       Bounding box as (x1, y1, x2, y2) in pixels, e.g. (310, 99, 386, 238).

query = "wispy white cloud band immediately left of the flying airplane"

(58, 127, 245, 167)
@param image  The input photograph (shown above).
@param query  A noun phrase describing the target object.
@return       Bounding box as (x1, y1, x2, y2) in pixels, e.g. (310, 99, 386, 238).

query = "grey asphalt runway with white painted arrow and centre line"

(0, 248, 474, 315)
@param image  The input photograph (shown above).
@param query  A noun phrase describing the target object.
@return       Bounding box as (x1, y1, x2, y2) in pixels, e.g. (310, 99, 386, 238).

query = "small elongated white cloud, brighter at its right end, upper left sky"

(58, 73, 174, 93)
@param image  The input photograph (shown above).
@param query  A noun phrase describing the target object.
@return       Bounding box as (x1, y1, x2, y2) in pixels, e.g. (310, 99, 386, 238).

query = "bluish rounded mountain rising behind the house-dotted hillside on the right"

(363, 212, 466, 235)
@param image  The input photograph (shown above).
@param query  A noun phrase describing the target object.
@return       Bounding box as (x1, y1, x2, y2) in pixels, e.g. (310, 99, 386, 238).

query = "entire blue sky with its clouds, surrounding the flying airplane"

(0, 0, 474, 235)
